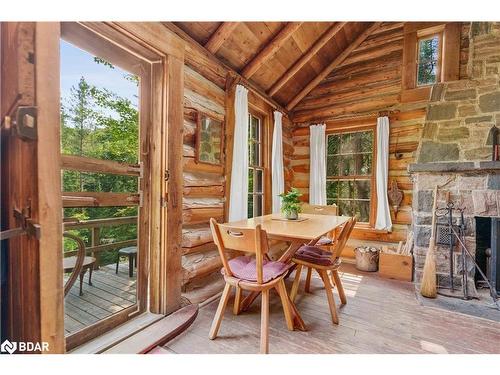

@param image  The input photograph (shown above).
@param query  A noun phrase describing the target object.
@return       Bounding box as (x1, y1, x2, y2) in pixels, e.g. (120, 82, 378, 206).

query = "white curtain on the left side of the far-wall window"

(309, 124, 326, 205)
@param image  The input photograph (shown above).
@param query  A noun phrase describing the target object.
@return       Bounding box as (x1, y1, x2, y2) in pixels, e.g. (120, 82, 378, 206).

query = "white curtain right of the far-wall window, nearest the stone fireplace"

(375, 116, 392, 231)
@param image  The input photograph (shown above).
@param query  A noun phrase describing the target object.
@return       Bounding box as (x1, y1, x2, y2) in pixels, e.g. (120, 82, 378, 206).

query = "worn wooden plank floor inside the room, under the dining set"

(165, 264, 500, 353)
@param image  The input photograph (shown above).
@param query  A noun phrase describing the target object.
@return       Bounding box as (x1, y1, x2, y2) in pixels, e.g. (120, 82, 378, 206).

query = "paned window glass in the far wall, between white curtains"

(326, 130, 374, 223)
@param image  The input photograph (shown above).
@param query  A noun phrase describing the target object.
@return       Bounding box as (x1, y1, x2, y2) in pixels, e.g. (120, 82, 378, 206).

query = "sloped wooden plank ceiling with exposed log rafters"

(174, 22, 391, 110)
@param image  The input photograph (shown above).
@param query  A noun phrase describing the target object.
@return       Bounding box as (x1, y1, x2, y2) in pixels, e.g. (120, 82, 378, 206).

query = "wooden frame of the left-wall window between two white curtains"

(247, 109, 266, 217)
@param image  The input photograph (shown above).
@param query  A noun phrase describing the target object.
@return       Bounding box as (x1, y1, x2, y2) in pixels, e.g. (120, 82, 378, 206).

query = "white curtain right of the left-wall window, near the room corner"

(272, 111, 285, 214)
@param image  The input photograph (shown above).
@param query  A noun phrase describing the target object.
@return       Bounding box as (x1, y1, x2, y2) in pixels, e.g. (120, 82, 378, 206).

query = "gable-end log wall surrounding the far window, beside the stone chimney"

(291, 23, 469, 247)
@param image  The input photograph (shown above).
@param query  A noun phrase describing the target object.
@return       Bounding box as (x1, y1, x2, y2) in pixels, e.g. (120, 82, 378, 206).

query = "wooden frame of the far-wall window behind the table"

(325, 124, 377, 229)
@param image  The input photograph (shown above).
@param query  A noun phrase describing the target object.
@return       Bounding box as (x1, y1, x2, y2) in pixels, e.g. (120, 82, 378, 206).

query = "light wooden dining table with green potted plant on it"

(229, 214, 350, 331)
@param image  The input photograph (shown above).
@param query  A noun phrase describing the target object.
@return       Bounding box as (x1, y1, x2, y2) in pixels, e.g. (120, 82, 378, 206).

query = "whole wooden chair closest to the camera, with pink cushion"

(209, 218, 293, 353)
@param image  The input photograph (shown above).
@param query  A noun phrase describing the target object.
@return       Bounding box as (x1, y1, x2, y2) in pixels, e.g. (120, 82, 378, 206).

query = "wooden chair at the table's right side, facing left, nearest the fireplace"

(290, 218, 356, 324)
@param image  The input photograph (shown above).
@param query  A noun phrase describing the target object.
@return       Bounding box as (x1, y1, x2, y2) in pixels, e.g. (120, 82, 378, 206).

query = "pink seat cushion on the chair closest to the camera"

(229, 256, 292, 283)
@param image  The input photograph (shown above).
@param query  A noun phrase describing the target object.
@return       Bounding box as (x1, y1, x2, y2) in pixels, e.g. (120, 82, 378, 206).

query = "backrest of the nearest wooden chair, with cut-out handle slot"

(210, 218, 269, 284)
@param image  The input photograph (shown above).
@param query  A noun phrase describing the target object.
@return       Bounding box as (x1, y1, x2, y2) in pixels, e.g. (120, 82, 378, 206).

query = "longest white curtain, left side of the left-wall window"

(229, 85, 248, 221)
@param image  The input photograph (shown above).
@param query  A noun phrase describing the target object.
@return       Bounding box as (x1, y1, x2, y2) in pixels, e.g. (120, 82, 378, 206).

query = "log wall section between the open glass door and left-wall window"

(182, 66, 225, 290)
